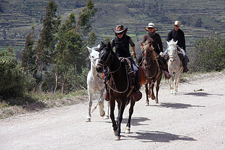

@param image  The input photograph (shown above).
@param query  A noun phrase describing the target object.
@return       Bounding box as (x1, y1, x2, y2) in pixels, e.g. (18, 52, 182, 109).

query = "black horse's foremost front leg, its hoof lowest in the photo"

(115, 99, 126, 140)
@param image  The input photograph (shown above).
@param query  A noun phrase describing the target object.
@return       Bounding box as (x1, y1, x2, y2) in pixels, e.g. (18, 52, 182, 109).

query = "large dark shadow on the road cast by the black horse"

(129, 131, 196, 142)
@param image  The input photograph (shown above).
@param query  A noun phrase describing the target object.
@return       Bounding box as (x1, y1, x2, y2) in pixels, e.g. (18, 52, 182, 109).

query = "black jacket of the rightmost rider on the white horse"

(167, 29, 186, 50)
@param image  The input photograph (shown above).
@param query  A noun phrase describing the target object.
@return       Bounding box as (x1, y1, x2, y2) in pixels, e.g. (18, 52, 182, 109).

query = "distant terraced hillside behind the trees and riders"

(0, 0, 225, 51)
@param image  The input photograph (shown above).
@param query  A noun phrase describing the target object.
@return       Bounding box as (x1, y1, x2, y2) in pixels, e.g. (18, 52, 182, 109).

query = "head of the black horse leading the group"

(96, 42, 113, 72)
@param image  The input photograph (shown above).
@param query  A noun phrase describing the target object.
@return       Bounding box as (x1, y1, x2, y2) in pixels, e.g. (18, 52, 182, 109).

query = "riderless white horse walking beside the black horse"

(86, 46, 109, 122)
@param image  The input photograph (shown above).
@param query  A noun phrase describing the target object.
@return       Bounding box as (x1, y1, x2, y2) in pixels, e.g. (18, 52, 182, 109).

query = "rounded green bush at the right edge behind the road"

(189, 33, 225, 72)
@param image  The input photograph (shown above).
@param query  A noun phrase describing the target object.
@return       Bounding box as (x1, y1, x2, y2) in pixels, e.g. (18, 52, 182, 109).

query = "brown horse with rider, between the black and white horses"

(141, 43, 162, 105)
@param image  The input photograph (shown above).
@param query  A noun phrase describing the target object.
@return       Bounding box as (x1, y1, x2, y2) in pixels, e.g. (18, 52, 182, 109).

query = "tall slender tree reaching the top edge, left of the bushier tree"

(35, 0, 60, 90)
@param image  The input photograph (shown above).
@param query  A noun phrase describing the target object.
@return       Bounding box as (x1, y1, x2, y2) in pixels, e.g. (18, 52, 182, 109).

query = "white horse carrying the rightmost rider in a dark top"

(167, 39, 183, 94)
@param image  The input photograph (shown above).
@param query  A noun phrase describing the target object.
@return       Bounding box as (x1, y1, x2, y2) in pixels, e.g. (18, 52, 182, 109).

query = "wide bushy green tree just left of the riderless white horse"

(54, 0, 97, 93)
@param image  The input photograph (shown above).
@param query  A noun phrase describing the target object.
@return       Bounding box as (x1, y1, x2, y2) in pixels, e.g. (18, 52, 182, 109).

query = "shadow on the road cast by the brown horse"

(155, 103, 205, 109)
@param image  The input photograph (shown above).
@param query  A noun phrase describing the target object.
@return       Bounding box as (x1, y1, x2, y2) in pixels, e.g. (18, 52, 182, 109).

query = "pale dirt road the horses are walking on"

(0, 73, 225, 150)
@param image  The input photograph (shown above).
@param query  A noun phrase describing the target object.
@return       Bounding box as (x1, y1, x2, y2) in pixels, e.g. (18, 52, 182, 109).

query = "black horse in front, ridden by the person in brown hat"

(96, 43, 135, 140)
